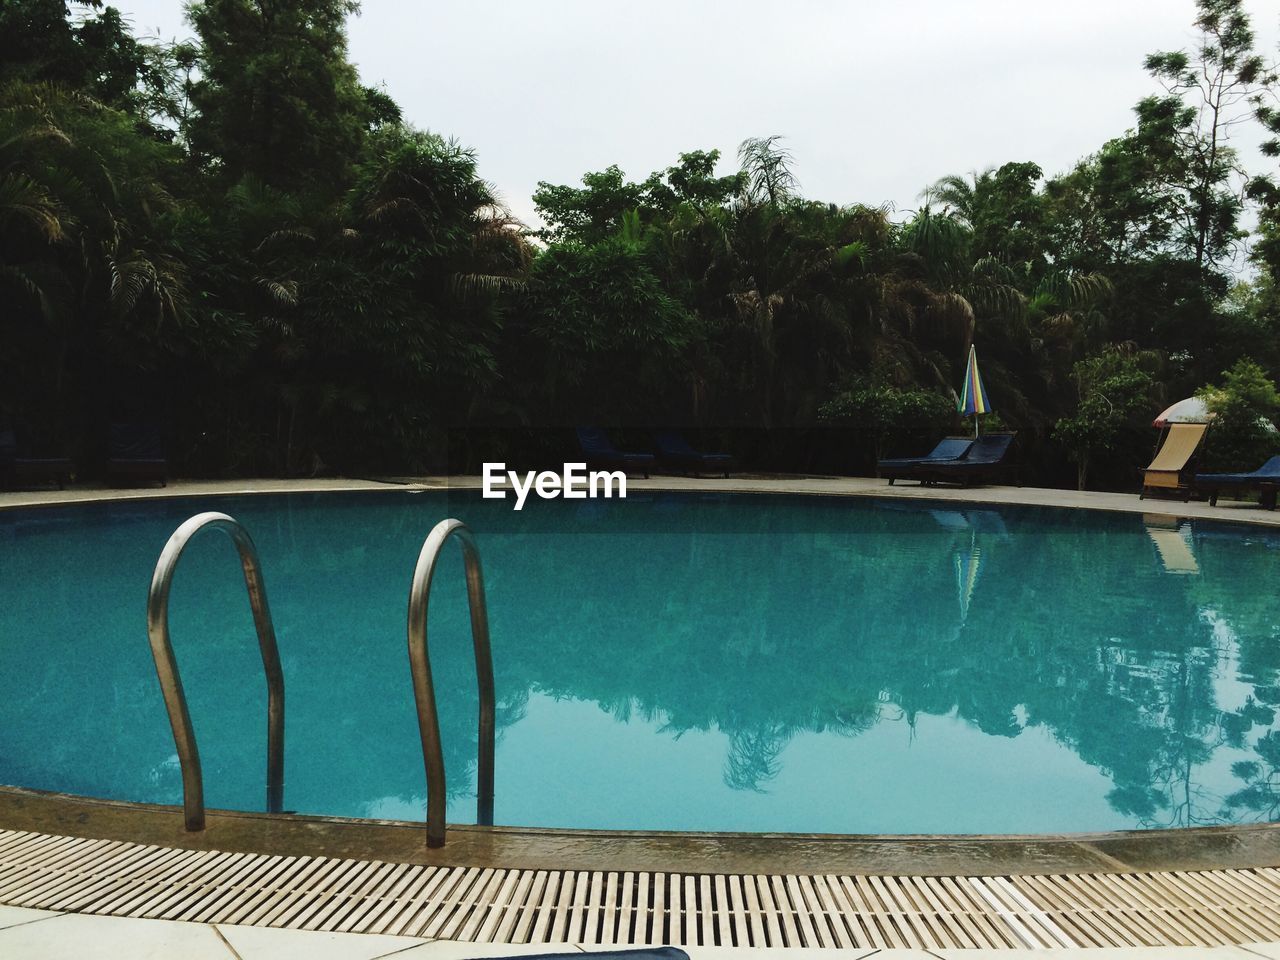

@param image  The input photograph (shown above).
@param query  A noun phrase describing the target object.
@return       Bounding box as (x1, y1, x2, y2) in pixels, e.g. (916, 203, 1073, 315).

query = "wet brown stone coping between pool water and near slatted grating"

(0, 786, 1280, 877)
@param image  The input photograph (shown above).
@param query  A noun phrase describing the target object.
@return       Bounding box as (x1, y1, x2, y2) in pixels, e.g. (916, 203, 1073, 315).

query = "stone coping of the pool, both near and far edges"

(0, 476, 1280, 876)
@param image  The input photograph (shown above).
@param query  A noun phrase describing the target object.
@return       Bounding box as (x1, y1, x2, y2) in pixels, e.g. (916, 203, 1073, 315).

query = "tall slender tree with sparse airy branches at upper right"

(1044, 0, 1270, 392)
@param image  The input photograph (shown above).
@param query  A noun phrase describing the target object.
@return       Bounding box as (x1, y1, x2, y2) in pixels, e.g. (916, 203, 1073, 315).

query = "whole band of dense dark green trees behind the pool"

(0, 0, 1280, 486)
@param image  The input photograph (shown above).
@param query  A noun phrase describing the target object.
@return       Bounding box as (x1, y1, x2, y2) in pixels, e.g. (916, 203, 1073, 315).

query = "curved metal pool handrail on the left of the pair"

(147, 513, 284, 831)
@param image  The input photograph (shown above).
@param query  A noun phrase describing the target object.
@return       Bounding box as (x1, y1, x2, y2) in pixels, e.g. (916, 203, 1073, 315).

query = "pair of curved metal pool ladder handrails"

(147, 512, 494, 847)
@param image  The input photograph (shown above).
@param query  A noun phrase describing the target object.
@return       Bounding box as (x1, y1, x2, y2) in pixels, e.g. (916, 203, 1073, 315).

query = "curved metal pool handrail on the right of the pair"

(408, 520, 494, 847)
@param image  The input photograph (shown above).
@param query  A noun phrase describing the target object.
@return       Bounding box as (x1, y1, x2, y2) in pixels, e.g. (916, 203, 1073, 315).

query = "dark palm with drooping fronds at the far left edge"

(0, 82, 187, 444)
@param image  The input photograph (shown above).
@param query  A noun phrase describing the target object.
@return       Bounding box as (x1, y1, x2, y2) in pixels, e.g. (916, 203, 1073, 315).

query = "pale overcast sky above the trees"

(111, 0, 1280, 221)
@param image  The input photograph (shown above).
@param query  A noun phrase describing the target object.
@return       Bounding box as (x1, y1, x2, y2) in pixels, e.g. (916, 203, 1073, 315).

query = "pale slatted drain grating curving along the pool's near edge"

(0, 831, 1280, 948)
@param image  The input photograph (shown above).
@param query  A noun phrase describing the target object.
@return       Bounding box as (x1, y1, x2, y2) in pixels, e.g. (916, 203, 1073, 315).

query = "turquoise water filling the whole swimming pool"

(0, 492, 1280, 833)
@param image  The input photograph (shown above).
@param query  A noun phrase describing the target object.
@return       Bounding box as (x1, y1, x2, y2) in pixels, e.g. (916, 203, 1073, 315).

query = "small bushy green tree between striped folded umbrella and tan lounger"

(1053, 347, 1153, 490)
